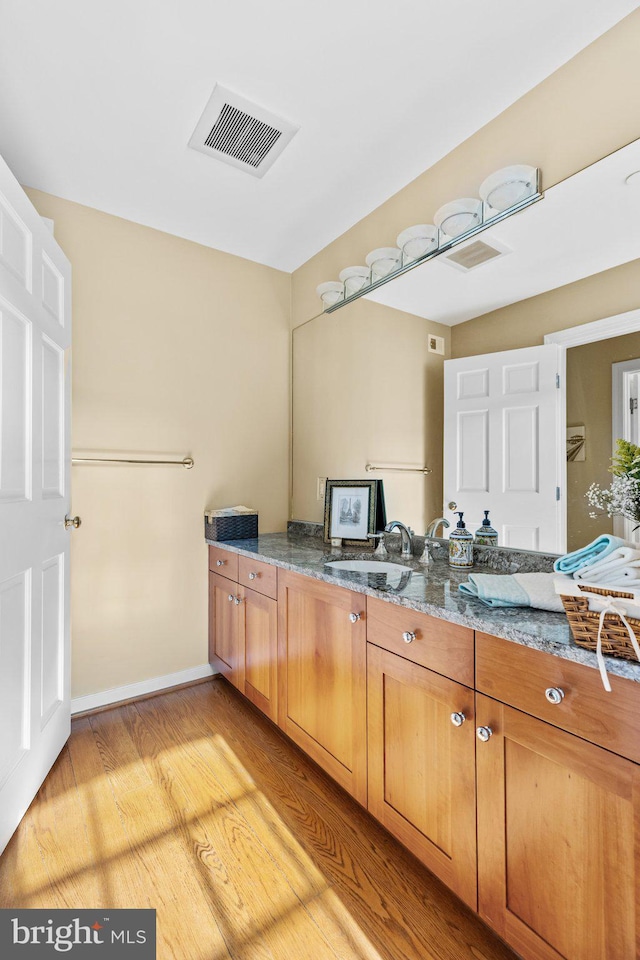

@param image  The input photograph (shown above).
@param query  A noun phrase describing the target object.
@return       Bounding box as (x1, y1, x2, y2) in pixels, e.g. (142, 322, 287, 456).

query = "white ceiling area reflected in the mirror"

(367, 140, 640, 326)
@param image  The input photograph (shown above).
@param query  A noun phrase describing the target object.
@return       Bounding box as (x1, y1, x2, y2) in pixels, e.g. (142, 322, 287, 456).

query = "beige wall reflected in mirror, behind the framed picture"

(292, 299, 450, 534)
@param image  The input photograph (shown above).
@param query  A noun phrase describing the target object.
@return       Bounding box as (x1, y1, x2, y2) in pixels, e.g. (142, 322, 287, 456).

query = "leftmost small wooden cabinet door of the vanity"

(209, 573, 244, 691)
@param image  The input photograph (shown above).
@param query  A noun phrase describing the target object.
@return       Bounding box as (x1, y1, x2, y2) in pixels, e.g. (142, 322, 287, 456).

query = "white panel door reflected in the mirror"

(444, 344, 566, 553)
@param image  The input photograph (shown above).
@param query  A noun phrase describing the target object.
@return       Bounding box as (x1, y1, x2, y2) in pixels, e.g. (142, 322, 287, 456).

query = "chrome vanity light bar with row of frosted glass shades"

(316, 163, 540, 313)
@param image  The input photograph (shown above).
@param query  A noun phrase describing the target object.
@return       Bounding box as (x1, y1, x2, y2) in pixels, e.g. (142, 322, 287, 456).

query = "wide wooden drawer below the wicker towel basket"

(476, 633, 640, 762)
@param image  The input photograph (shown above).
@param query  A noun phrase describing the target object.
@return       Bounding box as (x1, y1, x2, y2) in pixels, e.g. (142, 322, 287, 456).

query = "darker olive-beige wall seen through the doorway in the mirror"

(567, 333, 640, 550)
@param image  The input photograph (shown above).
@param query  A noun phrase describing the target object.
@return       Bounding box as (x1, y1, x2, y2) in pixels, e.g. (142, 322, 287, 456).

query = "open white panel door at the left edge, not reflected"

(0, 158, 71, 852)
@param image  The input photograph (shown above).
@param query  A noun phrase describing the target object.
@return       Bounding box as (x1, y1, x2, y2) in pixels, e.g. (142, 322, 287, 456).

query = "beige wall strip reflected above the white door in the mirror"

(451, 260, 640, 358)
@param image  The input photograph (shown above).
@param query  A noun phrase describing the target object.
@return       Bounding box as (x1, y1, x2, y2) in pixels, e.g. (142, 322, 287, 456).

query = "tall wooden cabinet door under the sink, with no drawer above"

(278, 571, 367, 805)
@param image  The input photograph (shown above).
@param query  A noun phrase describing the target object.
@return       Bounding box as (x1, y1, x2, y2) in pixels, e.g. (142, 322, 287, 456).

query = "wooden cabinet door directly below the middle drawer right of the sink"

(367, 643, 477, 910)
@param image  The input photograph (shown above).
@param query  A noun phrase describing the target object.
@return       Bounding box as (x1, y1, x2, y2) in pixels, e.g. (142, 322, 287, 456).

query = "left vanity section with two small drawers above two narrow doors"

(209, 547, 278, 722)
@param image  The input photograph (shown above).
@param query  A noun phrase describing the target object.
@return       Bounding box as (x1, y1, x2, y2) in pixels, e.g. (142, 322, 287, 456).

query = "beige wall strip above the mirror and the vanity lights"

(292, 10, 640, 326)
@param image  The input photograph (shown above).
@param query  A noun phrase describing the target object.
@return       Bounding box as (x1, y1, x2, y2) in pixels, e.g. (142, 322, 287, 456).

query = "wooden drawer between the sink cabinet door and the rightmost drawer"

(367, 597, 473, 687)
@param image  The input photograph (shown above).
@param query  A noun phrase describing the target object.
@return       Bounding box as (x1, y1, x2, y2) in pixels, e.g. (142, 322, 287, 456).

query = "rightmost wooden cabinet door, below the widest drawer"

(476, 695, 640, 960)
